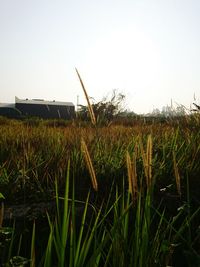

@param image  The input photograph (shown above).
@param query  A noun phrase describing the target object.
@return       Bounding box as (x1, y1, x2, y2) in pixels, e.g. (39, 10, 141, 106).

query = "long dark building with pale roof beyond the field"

(0, 97, 75, 119)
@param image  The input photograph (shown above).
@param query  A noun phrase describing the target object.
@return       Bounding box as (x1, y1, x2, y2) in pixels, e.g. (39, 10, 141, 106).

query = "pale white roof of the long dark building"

(15, 97, 74, 106)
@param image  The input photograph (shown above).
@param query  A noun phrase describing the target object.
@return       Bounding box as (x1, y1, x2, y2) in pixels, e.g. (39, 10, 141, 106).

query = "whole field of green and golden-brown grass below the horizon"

(0, 114, 200, 267)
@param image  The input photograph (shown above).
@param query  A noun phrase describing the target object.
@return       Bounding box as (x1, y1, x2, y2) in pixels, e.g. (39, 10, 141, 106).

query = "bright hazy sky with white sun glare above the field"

(0, 0, 200, 114)
